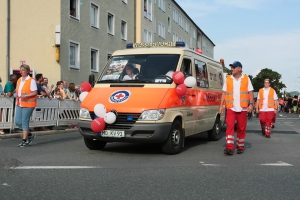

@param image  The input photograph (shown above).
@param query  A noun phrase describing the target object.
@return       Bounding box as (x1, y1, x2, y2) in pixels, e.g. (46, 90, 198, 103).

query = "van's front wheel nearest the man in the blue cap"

(162, 120, 184, 155)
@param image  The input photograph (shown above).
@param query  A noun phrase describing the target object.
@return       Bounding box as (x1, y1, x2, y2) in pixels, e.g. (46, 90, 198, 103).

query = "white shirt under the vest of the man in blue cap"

(222, 74, 253, 112)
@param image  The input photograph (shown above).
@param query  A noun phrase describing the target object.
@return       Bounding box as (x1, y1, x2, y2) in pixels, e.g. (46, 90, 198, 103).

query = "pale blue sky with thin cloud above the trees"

(176, 0, 300, 91)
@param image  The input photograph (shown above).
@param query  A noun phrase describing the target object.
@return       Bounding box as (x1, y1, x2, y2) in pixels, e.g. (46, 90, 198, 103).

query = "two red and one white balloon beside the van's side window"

(172, 71, 196, 96)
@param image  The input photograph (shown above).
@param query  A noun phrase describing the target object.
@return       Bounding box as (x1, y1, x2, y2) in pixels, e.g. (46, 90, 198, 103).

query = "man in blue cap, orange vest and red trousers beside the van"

(219, 61, 254, 155)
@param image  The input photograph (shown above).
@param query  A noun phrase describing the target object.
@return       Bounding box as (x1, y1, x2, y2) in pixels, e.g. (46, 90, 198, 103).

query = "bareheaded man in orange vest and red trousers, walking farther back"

(256, 79, 278, 138)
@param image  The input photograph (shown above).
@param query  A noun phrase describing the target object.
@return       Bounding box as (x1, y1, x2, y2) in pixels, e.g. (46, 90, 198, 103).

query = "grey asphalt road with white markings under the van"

(0, 114, 300, 200)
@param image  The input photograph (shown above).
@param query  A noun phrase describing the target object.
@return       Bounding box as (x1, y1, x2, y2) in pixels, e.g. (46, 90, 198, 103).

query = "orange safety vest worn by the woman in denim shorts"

(16, 77, 37, 108)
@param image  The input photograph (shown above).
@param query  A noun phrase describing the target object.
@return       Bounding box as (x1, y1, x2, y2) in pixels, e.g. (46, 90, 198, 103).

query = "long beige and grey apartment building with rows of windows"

(0, 0, 214, 84)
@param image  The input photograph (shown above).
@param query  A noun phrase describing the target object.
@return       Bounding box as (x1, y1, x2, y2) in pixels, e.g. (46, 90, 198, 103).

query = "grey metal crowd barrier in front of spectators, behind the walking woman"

(0, 97, 80, 132)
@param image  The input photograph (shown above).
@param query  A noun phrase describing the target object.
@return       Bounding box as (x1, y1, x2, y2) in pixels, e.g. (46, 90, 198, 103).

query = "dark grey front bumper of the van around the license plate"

(78, 121, 172, 143)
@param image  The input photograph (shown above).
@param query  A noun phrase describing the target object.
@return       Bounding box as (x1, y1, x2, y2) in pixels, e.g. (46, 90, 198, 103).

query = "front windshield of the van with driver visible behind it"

(97, 54, 180, 84)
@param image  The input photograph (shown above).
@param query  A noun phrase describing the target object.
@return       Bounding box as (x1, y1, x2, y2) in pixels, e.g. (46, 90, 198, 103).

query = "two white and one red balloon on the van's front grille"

(91, 103, 117, 132)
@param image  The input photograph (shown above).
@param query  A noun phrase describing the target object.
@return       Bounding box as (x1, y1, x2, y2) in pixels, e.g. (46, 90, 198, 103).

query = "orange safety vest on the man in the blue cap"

(225, 74, 250, 108)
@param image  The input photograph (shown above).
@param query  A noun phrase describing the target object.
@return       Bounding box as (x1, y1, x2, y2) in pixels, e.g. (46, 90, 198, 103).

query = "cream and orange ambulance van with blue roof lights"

(78, 42, 224, 154)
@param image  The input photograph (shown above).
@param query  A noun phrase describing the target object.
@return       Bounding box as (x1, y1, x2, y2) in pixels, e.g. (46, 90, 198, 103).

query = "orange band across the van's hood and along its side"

(81, 87, 222, 113)
